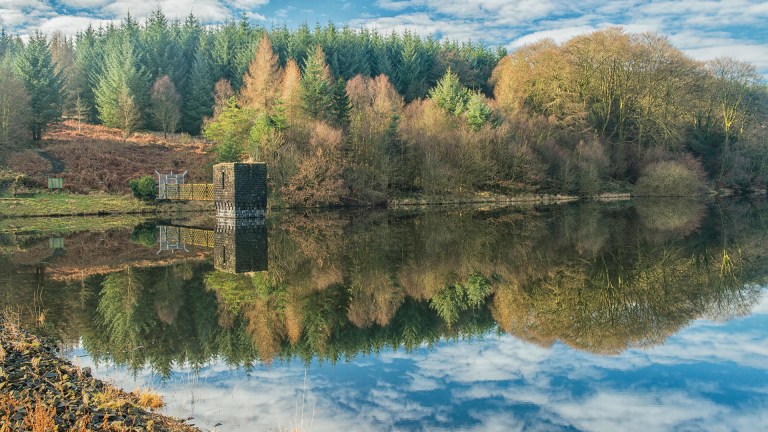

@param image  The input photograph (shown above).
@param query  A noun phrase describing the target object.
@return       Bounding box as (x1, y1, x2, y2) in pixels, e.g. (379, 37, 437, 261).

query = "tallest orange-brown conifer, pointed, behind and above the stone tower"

(240, 32, 282, 112)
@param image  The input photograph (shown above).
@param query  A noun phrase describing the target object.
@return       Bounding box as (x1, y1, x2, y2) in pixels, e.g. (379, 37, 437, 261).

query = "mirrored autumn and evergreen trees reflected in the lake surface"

(69, 204, 768, 373)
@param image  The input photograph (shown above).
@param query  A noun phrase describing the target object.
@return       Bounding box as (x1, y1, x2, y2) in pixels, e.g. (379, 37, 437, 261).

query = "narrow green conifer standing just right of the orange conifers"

(301, 45, 333, 120)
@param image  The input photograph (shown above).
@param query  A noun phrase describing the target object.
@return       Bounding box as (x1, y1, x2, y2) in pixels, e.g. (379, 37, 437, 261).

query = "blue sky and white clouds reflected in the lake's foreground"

(72, 295, 768, 432)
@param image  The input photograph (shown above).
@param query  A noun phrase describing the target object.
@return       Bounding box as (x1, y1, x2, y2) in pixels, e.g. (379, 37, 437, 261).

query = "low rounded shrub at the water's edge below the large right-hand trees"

(635, 159, 705, 197)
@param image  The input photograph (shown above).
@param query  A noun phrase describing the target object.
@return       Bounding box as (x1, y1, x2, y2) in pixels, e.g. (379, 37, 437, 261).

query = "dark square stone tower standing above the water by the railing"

(213, 163, 267, 219)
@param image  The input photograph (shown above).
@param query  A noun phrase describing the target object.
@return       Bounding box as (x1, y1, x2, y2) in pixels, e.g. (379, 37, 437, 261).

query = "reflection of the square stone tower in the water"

(213, 219, 269, 273)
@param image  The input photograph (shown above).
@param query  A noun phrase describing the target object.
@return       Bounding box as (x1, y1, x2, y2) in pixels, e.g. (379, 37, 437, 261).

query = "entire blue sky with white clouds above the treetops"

(0, 0, 768, 74)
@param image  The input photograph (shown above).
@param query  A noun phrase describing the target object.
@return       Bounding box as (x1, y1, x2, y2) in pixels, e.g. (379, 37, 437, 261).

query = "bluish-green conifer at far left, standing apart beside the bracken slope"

(16, 32, 63, 141)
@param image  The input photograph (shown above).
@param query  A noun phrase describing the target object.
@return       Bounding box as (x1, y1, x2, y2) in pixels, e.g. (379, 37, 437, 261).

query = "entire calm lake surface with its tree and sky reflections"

(0, 198, 768, 432)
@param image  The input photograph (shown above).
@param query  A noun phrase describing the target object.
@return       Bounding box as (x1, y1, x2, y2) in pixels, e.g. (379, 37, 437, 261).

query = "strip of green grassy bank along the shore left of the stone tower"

(0, 193, 211, 218)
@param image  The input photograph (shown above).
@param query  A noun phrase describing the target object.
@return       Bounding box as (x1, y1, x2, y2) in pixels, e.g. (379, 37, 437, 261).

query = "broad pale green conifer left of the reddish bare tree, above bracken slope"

(95, 38, 147, 131)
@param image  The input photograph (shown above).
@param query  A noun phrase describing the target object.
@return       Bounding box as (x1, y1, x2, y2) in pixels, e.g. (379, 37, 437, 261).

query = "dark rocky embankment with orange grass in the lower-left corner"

(0, 321, 198, 432)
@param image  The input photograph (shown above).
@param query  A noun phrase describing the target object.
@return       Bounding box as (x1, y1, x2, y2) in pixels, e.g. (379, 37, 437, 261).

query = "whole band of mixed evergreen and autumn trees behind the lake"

(0, 11, 768, 201)
